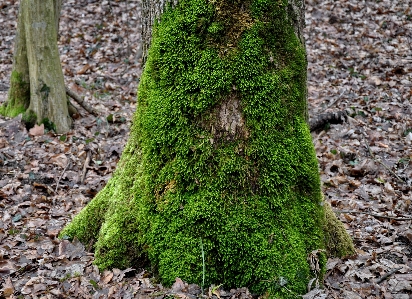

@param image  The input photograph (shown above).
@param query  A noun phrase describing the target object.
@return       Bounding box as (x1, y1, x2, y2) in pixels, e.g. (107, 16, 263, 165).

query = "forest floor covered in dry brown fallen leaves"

(0, 0, 412, 299)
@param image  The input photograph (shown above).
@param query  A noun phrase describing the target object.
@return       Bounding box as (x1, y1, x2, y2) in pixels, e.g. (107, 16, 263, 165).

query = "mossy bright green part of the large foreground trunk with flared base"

(61, 0, 353, 298)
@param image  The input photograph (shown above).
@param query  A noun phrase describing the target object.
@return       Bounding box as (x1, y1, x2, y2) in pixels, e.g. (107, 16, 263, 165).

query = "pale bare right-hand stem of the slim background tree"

(21, 0, 71, 133)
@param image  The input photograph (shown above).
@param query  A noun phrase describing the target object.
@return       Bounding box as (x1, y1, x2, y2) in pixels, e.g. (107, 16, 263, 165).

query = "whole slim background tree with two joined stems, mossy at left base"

(0, 0, 71, 133)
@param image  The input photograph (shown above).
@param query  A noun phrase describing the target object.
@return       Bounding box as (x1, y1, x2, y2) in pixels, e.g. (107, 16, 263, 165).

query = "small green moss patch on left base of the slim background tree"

(0, 71, 30, 117)
